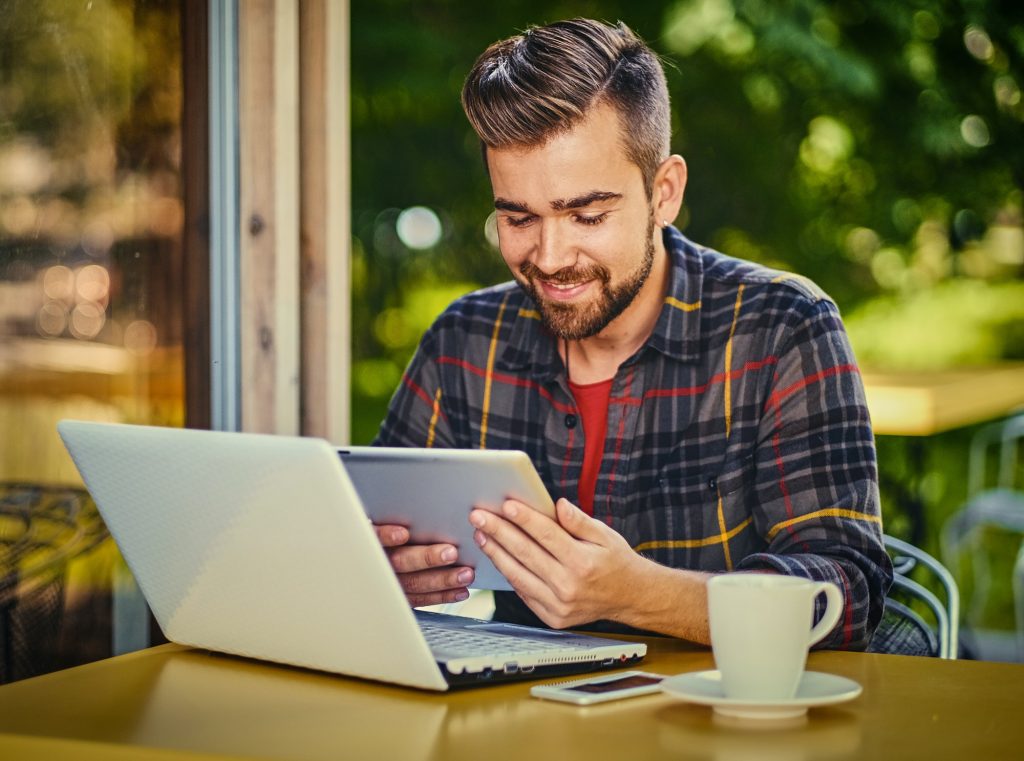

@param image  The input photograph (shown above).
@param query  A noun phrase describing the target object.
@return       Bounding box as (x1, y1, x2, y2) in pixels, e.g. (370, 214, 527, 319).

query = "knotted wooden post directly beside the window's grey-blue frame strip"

(239, 0, 299, 433)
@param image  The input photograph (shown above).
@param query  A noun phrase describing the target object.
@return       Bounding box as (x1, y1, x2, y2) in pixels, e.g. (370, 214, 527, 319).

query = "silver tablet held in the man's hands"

(338, 447, 555, 590)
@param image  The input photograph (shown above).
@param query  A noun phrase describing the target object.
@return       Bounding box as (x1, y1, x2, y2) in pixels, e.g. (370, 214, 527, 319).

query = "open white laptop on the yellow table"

(57, 420, 647, 690)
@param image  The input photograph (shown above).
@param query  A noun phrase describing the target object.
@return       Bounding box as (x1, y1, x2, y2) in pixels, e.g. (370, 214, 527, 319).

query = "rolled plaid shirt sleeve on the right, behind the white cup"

(736, 300, 892, 649)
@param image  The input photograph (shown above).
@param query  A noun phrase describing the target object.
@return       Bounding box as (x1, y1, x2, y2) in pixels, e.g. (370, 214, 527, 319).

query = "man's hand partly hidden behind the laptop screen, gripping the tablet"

(374, 524, 473, 607)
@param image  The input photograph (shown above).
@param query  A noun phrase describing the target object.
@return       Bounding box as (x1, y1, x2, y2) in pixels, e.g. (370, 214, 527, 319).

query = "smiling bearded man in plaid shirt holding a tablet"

(377, 19, 892, 648)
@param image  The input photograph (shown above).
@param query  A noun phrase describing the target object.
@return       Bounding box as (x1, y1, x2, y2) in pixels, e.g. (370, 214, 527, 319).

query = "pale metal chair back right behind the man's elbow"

(883, 535, 959, 660)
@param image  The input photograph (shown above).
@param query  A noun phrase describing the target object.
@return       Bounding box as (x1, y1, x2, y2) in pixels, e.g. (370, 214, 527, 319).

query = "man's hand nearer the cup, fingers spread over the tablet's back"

(470, 499, 653, 629)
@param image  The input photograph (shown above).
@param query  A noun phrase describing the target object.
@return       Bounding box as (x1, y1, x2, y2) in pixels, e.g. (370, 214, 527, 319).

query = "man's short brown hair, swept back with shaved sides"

(462, 18, 671, 198)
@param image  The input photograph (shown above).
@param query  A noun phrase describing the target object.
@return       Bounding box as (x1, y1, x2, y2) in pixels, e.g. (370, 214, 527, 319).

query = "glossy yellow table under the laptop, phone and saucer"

(0, 639, 1024, 761)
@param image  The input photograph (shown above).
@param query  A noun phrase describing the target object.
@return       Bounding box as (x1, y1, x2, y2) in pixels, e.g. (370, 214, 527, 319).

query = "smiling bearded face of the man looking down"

(487, 104, 665, 340)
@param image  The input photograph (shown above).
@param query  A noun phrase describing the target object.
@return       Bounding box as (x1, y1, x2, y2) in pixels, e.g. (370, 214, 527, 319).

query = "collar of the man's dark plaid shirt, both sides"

(497, 225, 703, 381)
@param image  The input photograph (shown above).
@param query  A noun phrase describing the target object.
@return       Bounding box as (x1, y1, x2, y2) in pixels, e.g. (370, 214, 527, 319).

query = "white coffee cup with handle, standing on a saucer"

(708, 574, 844, 701)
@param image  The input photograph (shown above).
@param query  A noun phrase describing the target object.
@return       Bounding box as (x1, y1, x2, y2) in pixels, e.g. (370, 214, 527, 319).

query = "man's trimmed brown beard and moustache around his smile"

(516, 217, 654, 341)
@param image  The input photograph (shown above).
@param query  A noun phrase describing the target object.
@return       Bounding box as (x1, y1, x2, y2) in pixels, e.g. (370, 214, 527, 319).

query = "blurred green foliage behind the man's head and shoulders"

(351, 0, 1024, 436)
